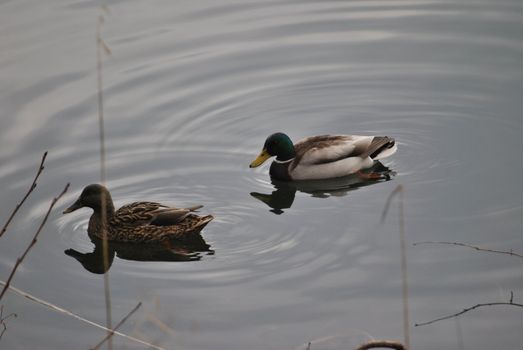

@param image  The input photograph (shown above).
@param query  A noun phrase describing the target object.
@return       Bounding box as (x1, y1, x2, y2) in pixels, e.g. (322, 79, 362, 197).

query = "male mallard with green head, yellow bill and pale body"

(250, 132, 397, 181)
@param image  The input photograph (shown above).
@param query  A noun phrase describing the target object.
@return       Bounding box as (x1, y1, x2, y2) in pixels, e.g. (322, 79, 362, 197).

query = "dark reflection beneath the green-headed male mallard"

(251, 162, 396, 215)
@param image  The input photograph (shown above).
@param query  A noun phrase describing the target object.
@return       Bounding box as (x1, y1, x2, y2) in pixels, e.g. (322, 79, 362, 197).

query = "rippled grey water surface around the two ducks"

(0, 0, 523, 350)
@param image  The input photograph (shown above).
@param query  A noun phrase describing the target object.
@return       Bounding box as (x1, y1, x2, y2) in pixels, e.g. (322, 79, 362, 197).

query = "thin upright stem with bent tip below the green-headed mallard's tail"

(381, 184, 410, 349)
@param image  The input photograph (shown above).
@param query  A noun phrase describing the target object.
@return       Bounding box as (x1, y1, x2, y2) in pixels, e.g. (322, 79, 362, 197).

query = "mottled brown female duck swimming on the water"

(63, 184, 213, 243)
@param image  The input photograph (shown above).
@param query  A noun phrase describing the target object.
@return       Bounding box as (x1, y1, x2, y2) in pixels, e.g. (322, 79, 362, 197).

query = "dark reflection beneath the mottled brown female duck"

(64, 234, 214, 274)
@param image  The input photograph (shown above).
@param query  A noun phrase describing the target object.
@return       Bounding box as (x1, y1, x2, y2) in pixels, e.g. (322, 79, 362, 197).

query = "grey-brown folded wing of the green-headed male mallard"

(295, 135, 374, 165)
